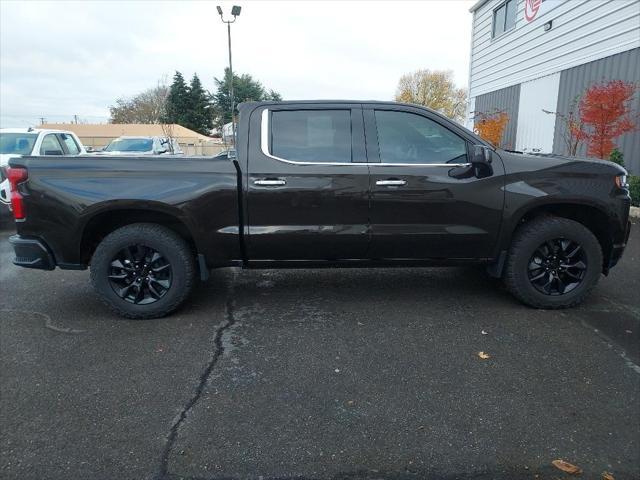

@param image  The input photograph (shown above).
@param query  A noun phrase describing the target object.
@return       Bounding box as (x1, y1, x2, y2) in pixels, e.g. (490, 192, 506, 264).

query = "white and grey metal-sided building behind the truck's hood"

(467, 0, 640, 175)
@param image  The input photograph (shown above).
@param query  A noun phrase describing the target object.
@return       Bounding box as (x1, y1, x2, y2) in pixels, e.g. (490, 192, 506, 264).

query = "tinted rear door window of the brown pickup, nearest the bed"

(271, 110, 351, 163)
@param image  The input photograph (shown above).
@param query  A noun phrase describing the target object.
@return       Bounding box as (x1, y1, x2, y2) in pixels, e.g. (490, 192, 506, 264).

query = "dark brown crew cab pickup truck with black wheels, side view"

(3, 101, 630, 318)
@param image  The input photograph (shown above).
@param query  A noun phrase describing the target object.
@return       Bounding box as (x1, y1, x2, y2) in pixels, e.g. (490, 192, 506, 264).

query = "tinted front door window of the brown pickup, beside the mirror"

(375, 110, 467, 163)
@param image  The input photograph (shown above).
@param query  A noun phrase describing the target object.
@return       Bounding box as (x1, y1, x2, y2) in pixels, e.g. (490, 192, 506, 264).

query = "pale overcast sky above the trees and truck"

(0, 0, 474, 127)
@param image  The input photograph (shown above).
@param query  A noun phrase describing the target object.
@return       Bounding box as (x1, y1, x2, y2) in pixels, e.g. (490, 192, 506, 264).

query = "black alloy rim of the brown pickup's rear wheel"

(108, 244, 173, 305)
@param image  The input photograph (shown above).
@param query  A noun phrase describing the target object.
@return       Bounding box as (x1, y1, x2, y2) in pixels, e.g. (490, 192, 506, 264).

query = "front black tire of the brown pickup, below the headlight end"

(504, 216, 602, 309)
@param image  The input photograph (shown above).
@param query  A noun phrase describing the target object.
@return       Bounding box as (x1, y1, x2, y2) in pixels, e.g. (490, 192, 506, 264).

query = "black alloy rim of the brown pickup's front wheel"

(528, 238, 588, 296)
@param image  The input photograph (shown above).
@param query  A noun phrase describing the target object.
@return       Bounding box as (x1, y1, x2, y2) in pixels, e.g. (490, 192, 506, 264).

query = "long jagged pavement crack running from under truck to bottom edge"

(153, 275, 235, 480)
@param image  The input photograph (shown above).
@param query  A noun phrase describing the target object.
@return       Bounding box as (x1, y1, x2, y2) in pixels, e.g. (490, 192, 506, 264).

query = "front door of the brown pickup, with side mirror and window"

(364, 105, 504, 259)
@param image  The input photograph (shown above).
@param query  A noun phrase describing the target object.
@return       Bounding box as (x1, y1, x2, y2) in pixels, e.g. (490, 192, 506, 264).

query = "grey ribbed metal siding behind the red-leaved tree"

(553, 48, 640, 175)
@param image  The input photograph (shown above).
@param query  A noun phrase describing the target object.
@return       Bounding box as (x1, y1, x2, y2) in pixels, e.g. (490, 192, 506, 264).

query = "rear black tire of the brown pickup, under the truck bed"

(91, 223, 195, 319)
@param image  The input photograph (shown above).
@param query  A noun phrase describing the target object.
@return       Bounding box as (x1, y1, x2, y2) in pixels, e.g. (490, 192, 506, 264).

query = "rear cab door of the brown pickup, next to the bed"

(245, 103, 369, 262)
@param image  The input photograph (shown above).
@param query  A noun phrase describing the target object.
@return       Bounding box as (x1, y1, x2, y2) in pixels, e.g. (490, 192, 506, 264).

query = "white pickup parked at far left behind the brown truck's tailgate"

(0, 128, 87, 204)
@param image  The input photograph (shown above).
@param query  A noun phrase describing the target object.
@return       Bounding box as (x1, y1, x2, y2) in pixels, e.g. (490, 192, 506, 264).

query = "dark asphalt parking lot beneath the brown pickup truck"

(0, 225, 640, 480)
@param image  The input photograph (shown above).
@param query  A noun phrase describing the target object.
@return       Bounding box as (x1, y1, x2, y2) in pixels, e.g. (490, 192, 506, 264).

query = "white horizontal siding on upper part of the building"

(469, 0, 640, 97)
